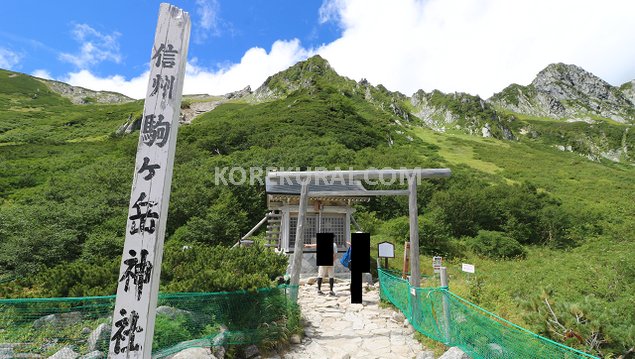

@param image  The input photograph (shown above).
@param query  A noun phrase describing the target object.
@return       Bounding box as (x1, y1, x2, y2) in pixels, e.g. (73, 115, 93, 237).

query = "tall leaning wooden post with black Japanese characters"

(108, 4, 190, 359)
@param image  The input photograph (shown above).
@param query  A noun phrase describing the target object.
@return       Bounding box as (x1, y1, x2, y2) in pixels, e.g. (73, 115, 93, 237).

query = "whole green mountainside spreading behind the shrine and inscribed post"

(0, 57, 635, 355)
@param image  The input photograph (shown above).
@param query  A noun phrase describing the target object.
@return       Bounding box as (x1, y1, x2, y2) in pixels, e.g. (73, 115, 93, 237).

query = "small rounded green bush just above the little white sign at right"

(470, 231, 527, 259)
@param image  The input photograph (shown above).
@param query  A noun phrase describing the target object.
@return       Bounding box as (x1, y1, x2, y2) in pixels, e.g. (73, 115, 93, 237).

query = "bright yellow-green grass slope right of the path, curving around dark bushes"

(402, 129, 635, 350)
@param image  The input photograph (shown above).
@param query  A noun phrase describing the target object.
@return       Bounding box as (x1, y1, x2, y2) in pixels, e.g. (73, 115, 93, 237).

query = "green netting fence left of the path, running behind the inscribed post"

(0, 285, 299, 358)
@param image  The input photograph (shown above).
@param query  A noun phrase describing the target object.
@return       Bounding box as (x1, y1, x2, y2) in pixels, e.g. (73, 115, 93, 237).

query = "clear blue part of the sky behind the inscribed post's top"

(0, 0, 339, 77)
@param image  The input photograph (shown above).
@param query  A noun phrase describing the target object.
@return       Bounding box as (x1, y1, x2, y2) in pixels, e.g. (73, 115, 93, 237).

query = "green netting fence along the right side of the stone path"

(378, 268, 597, 359)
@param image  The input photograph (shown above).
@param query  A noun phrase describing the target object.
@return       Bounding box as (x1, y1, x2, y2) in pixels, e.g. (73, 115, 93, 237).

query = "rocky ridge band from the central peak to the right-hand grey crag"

(248, 56, 635, 163)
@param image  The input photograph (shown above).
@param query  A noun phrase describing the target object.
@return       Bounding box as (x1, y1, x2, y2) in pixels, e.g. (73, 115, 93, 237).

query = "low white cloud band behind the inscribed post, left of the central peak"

(54, 40, 310, 99)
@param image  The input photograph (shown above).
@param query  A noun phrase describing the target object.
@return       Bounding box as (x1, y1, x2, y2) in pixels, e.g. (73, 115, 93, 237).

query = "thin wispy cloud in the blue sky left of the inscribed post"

(59, 24, 122, 69)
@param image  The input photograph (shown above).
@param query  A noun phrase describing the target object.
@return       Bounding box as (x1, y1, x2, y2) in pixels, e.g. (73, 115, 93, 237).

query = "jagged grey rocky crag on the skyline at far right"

(490, 63, 635, 123)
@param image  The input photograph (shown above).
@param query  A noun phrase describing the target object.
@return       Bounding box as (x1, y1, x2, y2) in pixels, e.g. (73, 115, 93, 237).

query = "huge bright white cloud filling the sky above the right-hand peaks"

(318, 0, 635, 97)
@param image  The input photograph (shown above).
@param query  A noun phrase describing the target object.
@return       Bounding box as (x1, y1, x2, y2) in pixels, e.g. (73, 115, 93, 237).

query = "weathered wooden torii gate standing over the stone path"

(267, 168, 451, 300)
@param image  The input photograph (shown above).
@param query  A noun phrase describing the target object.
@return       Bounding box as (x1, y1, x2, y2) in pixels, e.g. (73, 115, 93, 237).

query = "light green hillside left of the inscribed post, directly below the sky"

(0, 70, 142, 203)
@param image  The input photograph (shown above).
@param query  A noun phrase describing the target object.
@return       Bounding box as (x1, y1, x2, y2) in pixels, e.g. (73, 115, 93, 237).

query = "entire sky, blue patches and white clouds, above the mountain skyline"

(0, 0, 635, 98)
